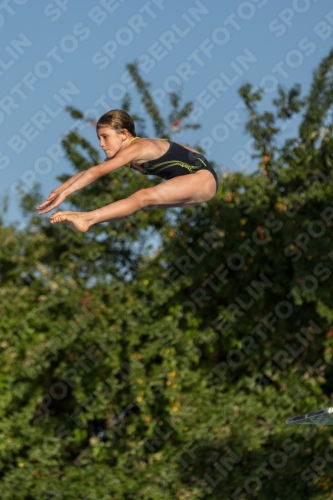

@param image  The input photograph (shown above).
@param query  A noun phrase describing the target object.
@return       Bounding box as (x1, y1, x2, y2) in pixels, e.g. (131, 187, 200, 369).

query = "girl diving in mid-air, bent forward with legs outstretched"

(37, 109, 218, 233)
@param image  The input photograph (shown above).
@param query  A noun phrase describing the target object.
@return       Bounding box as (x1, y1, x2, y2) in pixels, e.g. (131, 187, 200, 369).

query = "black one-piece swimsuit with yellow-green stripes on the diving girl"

(129, 141, 218, 195)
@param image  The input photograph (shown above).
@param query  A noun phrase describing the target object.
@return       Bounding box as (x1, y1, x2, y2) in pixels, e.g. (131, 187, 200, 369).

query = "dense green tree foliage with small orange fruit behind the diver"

(0, 53, 333, 500)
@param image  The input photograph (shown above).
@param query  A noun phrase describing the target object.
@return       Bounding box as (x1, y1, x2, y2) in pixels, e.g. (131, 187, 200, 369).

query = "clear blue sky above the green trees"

(0, 0, 333, 225)
